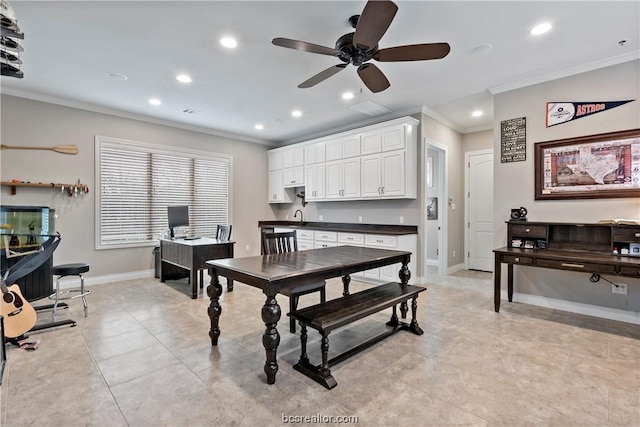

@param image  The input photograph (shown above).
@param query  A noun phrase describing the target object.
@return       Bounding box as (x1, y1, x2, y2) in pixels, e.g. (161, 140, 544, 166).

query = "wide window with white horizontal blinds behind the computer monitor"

(96, 136, 231, 249)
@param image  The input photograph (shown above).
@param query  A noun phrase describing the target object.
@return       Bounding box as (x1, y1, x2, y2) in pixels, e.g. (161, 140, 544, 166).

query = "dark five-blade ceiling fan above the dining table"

(271, 0, 451, 93)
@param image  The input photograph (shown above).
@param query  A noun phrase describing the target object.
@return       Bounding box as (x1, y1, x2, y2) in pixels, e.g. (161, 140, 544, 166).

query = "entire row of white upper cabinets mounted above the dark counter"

(269, 117, 419, 203)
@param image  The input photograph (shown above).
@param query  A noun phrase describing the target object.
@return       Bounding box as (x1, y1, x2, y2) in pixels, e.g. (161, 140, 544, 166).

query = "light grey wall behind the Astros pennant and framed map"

(494, 61, 640, 312)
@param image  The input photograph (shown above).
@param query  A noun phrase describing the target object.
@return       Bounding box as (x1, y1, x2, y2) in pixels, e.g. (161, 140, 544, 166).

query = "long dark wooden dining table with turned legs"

(207, 246, 411, 384)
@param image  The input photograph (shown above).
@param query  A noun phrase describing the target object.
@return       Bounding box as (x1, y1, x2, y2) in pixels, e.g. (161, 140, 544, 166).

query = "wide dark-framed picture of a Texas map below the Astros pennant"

(534, 129, 640, 200)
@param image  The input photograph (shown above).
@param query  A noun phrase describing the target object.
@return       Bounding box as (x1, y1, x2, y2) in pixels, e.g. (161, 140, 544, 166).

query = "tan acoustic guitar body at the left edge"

(0, 285, 38, 338)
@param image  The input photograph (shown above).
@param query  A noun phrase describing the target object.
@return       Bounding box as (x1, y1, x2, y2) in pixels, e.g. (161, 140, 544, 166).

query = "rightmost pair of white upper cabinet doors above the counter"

(361, 150, 406, 199)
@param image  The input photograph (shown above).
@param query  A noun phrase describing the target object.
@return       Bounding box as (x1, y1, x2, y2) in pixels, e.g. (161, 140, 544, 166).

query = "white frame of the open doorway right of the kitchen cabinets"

(420, 137, 449, 277)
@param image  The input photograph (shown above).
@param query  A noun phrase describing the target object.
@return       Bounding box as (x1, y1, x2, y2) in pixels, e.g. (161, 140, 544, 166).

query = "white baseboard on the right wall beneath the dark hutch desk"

(501, 290, 640, 325)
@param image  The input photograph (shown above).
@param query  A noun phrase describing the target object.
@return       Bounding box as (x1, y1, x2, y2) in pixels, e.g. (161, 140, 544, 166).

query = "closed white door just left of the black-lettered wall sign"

(467, 150, 493, 271)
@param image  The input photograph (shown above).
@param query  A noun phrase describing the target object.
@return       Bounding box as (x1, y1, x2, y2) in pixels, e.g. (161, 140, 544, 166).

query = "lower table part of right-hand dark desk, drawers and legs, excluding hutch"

(493, 247, 640, 313)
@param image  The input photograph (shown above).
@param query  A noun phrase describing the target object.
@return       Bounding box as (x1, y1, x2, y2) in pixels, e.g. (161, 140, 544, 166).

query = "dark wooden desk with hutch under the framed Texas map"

(493, 221, 640, 312)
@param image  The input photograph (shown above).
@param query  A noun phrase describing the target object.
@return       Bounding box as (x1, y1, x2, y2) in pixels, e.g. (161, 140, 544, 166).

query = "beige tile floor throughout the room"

(0, 272, 640, 426)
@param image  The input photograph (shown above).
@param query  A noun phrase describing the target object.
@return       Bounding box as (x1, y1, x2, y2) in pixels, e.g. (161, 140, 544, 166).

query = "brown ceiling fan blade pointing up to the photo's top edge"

(353, 0, 398, 50)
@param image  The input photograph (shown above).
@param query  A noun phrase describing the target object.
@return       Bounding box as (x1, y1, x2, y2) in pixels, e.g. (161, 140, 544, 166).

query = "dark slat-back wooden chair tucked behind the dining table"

(262, 230, 327, 333)
